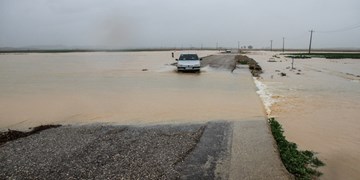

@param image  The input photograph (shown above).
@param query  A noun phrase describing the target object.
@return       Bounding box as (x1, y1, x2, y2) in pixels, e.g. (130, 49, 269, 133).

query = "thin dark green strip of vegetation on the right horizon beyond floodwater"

(283, 53, 360, 59)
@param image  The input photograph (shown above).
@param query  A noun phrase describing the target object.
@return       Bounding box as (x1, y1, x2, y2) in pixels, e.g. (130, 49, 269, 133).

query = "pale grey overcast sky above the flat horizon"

(0, 0, 360, 48)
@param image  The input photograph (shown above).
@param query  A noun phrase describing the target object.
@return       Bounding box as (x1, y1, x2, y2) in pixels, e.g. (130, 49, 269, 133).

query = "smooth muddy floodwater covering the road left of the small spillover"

(0, 51, 265, 130)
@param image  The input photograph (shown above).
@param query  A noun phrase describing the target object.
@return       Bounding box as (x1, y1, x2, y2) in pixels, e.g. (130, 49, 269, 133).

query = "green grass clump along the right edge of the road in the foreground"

(269, 118, 325, 179)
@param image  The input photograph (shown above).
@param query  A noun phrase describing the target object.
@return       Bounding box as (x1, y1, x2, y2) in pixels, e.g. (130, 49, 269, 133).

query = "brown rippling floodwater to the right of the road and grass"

(250, 52, 360, 179)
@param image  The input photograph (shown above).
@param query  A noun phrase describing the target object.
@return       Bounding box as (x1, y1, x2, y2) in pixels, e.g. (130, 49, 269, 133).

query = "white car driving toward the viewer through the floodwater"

(176, 54, 202, 72)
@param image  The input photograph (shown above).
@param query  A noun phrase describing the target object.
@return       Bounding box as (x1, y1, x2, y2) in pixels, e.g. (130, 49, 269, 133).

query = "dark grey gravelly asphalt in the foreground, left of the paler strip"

(0, 122, 231, 179)
